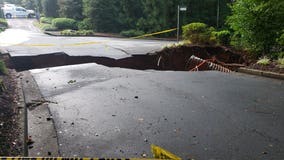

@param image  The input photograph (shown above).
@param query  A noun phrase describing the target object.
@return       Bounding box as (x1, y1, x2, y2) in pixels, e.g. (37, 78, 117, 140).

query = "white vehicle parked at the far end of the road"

(2, 4, 35, 18)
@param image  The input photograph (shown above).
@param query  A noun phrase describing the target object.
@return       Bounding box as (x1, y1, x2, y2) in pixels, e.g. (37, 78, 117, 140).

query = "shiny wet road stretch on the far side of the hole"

(0, 19, 174, 59)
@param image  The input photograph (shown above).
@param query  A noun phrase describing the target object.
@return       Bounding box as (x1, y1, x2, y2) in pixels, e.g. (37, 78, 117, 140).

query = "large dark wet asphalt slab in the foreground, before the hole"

(31, 64, 284, 159)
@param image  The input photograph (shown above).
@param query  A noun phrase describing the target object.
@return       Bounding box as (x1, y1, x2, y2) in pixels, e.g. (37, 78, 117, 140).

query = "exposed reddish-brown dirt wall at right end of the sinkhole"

(157, 45, 246, 71)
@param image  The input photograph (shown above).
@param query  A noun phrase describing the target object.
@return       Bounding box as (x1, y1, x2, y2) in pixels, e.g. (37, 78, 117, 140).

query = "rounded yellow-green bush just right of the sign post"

(182, 22, 216, 44)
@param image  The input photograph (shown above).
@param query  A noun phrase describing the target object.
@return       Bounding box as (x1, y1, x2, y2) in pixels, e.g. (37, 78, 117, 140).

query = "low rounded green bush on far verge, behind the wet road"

(52, 18, 78, 30)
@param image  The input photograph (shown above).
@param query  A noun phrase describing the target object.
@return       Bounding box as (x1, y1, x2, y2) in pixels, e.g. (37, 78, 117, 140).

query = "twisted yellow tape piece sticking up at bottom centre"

(151, 144, 181, 160)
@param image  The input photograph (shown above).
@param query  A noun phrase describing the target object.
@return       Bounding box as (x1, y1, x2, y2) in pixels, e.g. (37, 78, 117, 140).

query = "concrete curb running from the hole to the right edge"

(238, 67, 284, 80)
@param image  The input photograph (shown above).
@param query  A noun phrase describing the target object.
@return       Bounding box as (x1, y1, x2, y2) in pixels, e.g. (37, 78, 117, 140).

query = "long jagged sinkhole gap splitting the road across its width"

(5, 45, 245, 71)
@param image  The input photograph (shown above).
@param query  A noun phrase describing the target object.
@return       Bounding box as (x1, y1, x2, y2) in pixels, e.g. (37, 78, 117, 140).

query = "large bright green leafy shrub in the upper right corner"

(227, 0, 284, 54)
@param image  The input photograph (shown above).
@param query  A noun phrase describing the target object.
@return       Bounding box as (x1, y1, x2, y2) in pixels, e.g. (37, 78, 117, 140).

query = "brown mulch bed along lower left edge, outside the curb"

(0, 71, 23, 156)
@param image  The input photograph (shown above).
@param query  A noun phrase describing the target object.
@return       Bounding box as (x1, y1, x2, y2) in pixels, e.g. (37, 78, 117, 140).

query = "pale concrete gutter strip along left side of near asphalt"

(19, 71, 59, 157)
